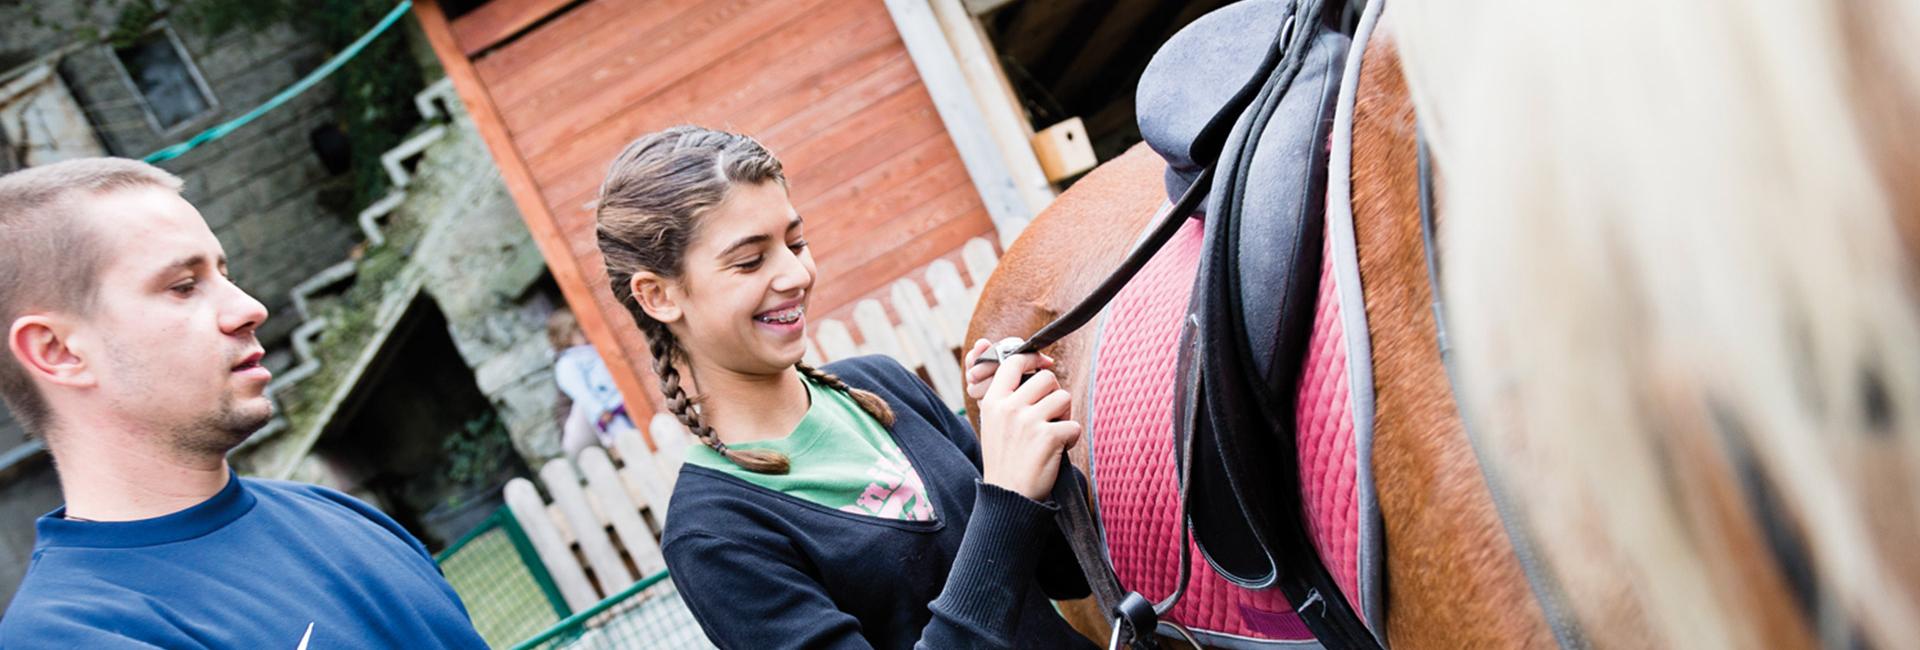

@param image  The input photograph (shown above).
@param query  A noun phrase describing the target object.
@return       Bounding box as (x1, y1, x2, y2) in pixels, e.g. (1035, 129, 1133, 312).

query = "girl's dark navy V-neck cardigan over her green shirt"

(662, 357, 1092, 650)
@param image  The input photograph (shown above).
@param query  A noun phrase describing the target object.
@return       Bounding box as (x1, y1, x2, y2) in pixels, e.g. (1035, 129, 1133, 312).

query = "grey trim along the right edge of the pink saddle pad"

(1327, 0, 1386, 646)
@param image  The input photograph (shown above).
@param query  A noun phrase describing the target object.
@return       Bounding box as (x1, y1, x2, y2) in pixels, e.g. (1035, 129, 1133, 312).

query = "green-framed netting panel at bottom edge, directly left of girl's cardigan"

(513, 571, 712, 650)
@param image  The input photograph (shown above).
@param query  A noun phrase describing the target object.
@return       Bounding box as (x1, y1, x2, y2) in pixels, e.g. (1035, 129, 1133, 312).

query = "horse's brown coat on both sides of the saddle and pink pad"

(968, 12, 1553, 648)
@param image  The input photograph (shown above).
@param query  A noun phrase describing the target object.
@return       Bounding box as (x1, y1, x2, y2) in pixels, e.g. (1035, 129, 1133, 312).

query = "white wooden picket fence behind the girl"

(505, 238, 998, 612)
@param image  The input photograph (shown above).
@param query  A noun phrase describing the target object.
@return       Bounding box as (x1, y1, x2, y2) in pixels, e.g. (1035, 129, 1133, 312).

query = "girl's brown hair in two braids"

(593, 127, 893, 474)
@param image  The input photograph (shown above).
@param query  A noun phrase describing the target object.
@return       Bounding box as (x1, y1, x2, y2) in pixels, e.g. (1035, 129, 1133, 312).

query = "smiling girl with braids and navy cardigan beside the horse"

(597, 127, 1091, 648)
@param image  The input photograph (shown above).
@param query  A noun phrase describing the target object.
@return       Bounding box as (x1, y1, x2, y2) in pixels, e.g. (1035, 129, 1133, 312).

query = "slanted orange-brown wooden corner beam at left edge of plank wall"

(413, 0, 660, 449)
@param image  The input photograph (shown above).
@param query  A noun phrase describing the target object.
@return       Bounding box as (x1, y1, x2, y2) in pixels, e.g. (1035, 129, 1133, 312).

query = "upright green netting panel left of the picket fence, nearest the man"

(436, 508, 568, 648)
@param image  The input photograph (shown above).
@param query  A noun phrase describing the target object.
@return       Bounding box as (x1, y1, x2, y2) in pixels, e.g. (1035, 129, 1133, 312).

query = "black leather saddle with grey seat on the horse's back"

(1137, 0, 1379, 648)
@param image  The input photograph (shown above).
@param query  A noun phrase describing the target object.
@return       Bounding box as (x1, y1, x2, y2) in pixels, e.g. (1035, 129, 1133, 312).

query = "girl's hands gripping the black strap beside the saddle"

(968, 348, 1081, 500)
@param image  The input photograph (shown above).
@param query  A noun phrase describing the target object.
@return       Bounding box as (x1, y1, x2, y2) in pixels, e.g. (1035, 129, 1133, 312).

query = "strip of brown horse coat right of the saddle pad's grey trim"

(1354, 15, 1553, 648)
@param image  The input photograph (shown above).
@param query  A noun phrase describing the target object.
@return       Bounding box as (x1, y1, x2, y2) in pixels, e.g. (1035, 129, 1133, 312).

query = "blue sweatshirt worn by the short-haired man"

(0, 477, 486, 650)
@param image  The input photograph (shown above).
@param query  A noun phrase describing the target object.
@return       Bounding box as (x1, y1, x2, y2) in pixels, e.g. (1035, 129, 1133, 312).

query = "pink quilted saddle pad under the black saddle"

(1089, 221, 1377, 644)
